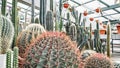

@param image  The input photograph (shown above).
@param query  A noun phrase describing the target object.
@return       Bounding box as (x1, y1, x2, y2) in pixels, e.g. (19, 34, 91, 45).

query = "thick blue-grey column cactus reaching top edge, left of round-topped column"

(39, 0, 47, 28)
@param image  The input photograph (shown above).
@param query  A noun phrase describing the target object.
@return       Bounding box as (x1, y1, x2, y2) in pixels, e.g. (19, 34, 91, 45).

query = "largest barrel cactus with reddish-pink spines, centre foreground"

(20, 32, 80, 68)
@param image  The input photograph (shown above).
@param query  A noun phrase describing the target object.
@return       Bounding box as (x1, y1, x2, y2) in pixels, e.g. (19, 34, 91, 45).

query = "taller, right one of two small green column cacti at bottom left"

(12, 47, 19, 68)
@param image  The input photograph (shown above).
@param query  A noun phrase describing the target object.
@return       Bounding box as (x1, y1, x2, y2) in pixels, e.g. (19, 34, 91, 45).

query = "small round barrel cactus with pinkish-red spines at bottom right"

(84, 53, 113, 68)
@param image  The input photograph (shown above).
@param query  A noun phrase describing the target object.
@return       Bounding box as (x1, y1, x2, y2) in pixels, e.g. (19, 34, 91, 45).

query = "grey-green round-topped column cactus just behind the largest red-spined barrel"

(46, 11, 54, 31)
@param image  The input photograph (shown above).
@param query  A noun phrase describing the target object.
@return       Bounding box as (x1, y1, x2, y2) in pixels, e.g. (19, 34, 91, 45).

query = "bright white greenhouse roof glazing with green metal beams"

(0, 0, 120, 21)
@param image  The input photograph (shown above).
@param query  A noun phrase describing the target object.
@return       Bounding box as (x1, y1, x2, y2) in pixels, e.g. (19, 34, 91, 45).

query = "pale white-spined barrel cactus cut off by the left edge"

(0, 15, 14, 54)
